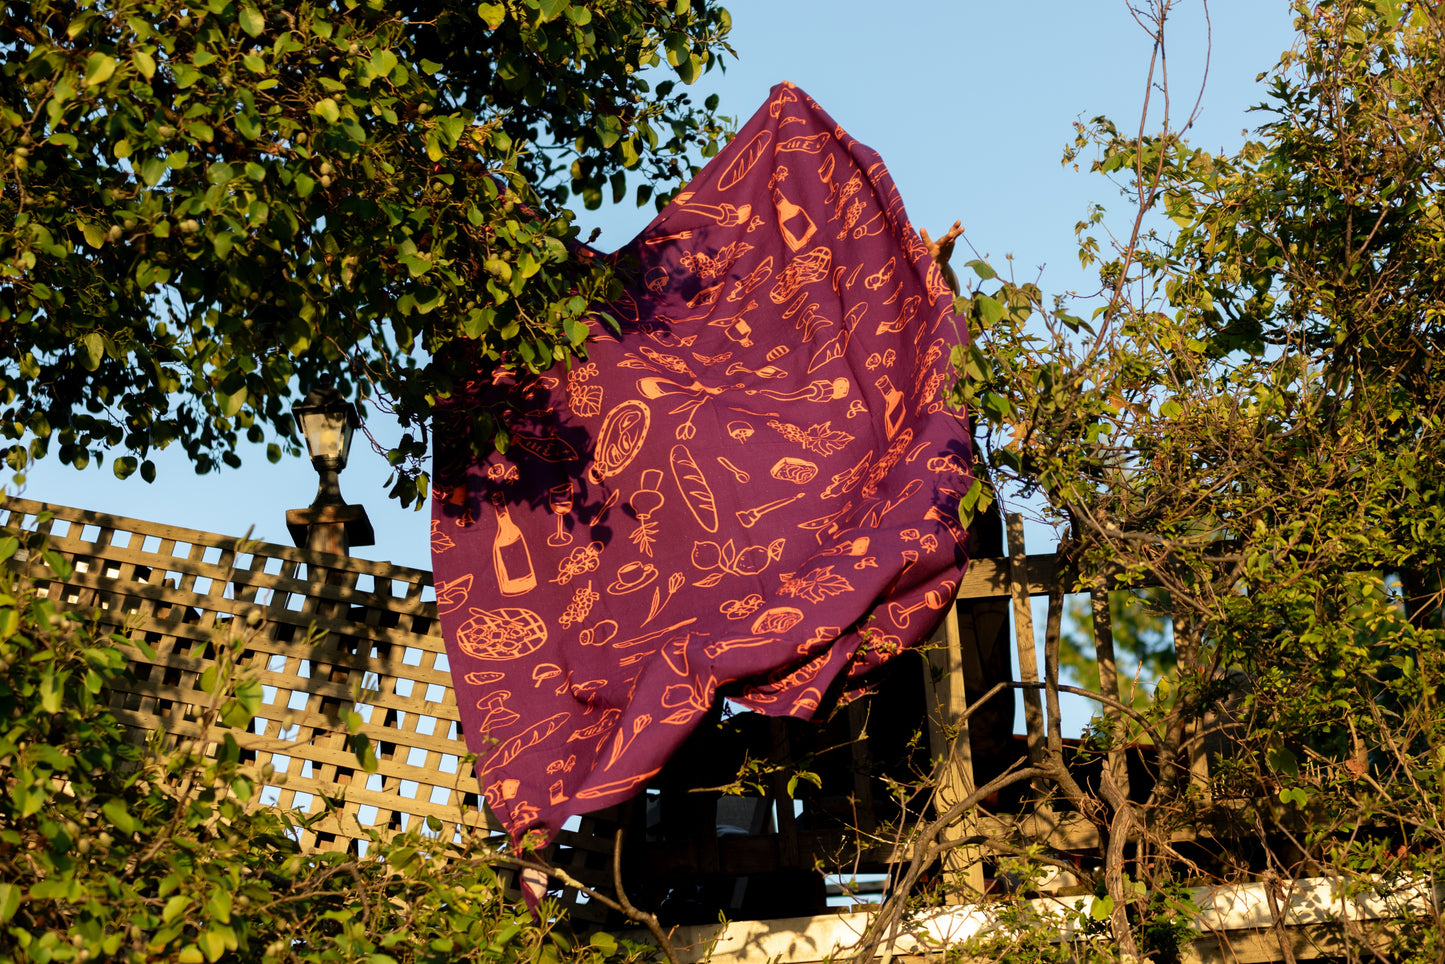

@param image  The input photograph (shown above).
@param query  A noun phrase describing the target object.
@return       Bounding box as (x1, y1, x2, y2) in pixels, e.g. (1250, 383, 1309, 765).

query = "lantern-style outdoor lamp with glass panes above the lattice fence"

(286, 386, 376, 555)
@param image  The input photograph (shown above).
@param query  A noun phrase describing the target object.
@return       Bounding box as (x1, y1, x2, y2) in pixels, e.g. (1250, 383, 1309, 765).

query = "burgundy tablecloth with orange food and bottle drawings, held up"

(432, 84, 971, 838)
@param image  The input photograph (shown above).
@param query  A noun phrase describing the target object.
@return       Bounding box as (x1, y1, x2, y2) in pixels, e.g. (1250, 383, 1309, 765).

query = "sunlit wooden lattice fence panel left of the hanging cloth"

(0, 499, 627, 916)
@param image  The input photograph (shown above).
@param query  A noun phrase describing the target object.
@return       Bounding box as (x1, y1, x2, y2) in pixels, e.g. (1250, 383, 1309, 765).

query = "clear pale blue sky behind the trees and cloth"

(20, 0, 1293, 578)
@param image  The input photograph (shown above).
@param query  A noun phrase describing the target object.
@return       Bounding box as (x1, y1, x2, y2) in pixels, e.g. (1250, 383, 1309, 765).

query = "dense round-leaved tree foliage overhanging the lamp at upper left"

(0, 0, 730, 502)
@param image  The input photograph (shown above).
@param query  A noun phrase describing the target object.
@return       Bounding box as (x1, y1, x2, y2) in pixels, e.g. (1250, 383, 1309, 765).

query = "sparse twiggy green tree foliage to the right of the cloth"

(930, 0, 1445, 960)
